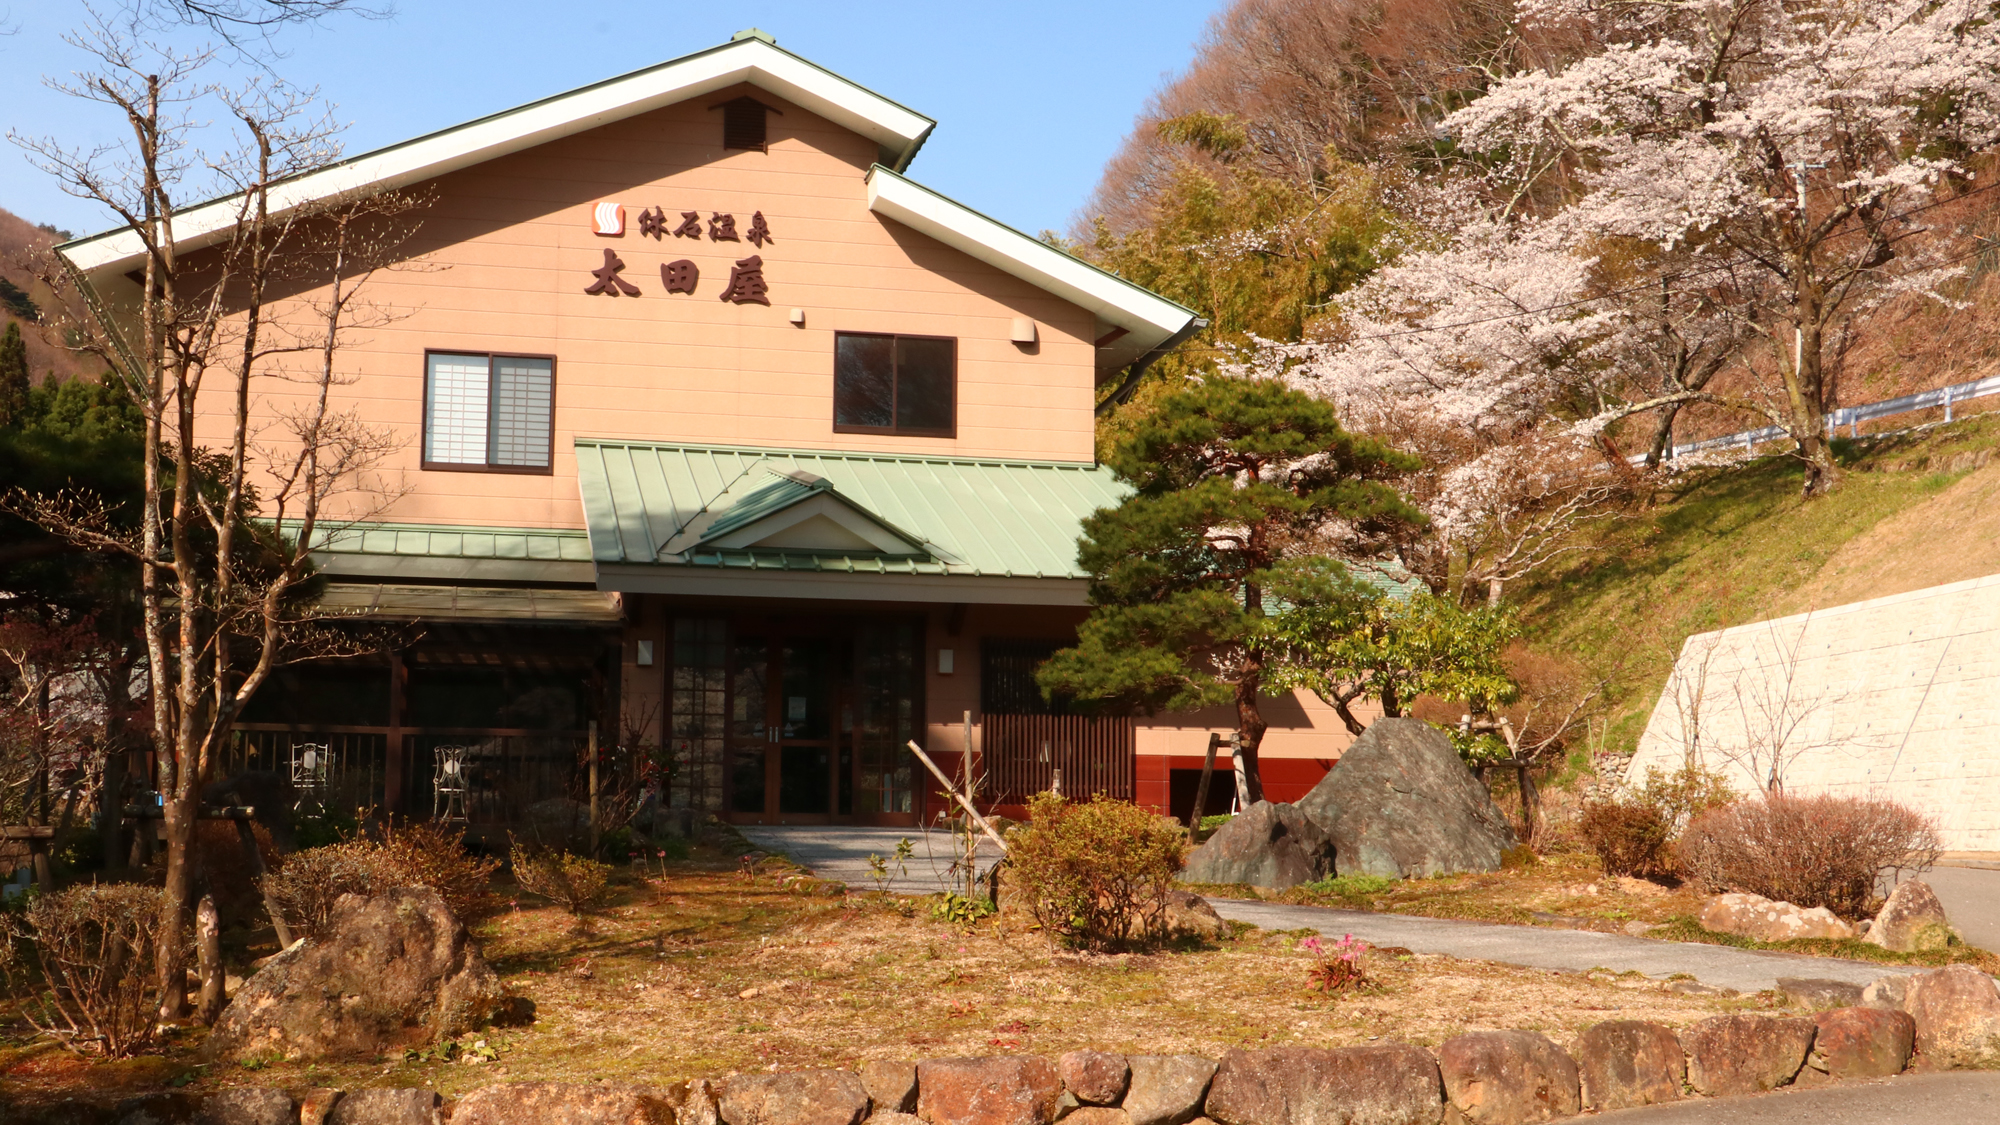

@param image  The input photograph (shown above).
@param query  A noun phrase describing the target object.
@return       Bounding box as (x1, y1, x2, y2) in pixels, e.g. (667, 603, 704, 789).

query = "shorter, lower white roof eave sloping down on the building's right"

(868, 164, 1196, 362)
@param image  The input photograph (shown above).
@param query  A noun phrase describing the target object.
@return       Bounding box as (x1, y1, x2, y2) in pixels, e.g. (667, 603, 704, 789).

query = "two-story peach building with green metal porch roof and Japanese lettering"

(62, 32, 1376, 823)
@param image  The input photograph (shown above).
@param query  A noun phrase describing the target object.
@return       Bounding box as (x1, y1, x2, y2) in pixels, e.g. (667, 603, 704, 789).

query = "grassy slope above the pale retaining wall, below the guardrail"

(1512, 414, 2000, 753)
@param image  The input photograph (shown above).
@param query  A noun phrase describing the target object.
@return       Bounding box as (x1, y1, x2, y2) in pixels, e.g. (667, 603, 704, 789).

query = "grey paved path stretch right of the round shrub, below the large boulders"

(1210, 899, 1908, 993)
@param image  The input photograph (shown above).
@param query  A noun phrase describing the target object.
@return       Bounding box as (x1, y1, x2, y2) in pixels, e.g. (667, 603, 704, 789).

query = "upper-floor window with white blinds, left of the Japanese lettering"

(424, 352, 556, 472)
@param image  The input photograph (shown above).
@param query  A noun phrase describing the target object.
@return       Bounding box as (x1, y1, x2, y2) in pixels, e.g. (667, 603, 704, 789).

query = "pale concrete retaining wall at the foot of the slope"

(1626, 575, 2000, 853)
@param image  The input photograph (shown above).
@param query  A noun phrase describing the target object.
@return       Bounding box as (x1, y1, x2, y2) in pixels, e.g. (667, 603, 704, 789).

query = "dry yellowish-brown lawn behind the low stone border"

(0, 844, 1776, 1099)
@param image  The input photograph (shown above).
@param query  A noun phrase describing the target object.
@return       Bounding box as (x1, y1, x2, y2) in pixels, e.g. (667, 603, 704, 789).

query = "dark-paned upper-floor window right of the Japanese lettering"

(834, 332, 958, 438)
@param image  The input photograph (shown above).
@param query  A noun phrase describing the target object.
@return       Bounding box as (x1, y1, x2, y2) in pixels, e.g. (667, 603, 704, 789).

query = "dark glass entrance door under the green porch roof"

(730, 635, 854, 812)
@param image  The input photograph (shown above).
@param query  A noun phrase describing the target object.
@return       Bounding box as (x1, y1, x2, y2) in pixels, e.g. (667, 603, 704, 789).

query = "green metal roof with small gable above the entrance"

(576, 438, 1126, 579)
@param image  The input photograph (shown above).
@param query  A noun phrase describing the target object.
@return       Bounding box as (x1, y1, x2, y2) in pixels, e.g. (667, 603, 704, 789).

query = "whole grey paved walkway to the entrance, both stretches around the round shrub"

(744, 827, 1902, 993)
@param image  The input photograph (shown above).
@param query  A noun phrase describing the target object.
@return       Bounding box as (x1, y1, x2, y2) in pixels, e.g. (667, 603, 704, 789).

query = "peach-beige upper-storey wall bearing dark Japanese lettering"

(204, 86, 1094, 526)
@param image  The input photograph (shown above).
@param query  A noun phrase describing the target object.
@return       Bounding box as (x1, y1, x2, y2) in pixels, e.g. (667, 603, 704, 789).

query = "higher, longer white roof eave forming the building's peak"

(60, 38, 936, 274)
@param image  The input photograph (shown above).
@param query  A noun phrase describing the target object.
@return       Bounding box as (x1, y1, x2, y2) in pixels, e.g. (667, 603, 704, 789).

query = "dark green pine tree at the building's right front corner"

(1038, 378, 1424, 801)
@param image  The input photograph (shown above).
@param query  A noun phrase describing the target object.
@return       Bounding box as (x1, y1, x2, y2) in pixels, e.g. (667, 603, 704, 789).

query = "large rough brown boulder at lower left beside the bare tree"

(202, 887, 506, 1059)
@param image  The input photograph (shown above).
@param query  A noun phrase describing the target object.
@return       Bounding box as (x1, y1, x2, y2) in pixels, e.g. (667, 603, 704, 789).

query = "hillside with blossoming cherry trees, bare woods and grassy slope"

(1064, 0, 2000, 764)
